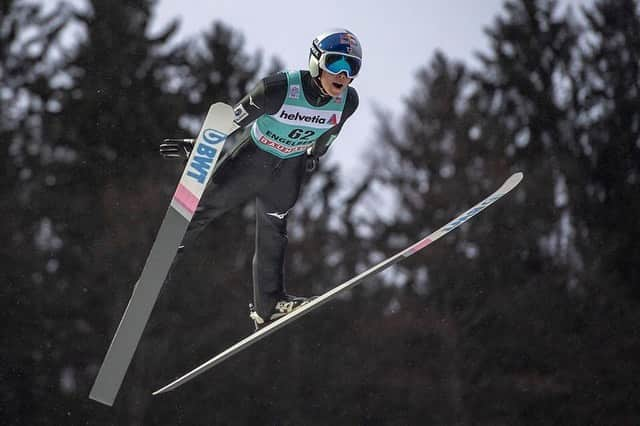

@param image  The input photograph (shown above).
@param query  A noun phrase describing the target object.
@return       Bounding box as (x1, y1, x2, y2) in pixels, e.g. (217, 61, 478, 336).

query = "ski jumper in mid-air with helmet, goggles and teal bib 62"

(160, 29, 362, 329)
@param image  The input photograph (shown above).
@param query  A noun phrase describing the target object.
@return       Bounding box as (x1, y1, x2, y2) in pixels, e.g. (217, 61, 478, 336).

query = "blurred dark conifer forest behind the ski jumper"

(0, 0, 640, 426)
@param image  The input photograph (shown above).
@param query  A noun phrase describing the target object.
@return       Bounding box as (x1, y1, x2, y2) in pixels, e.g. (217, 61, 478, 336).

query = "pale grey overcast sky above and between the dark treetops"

(152, 0, 516, 174)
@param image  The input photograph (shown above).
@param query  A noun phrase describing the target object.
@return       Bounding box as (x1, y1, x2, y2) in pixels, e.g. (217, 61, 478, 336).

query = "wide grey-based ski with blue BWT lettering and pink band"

(89, 103, 239, 405)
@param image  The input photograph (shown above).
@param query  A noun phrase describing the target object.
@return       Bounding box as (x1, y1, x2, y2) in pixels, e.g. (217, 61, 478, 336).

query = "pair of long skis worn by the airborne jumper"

(89, 103, 523, 405)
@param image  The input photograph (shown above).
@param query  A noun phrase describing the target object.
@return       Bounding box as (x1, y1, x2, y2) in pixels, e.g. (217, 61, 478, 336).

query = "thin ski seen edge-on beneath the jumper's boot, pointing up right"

(153, 173, 523, 395)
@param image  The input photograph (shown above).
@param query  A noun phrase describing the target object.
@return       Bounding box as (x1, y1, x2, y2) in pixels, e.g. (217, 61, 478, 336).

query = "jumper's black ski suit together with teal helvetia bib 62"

(182, 71, 358, 318)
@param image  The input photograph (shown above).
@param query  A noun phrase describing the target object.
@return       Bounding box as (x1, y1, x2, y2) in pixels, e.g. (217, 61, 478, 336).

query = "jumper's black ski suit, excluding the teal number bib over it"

(182, 71, 358, 318)
